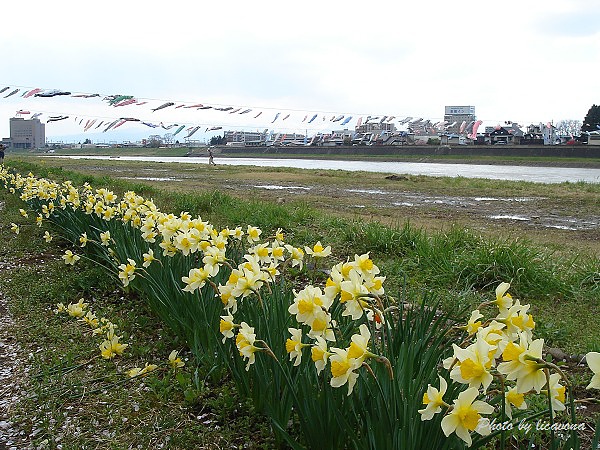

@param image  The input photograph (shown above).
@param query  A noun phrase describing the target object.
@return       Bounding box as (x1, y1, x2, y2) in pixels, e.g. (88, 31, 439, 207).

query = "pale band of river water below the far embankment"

(49, 156, 600, 183)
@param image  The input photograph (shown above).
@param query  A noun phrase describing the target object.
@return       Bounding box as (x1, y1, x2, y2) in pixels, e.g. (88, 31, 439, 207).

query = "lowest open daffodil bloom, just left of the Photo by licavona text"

(442, 387, 494, 447)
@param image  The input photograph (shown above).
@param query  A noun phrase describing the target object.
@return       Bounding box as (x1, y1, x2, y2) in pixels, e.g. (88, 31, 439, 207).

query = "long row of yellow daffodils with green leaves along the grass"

(0, 168, 600, 449)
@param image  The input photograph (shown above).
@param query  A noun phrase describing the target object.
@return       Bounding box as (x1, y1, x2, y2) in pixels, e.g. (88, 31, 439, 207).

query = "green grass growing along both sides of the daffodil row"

(0, 161, 600, 448)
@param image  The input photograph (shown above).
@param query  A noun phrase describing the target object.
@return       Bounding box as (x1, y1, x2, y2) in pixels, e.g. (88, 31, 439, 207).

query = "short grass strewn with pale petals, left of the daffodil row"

(0, 191, 274, 449)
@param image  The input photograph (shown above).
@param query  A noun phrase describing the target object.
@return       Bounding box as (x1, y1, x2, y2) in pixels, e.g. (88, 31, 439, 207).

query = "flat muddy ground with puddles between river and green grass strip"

(21, 158, 600, 255)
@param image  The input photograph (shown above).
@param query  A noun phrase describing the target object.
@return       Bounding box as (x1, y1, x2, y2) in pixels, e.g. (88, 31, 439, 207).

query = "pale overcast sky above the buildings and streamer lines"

(0, 0, 600, 142)
